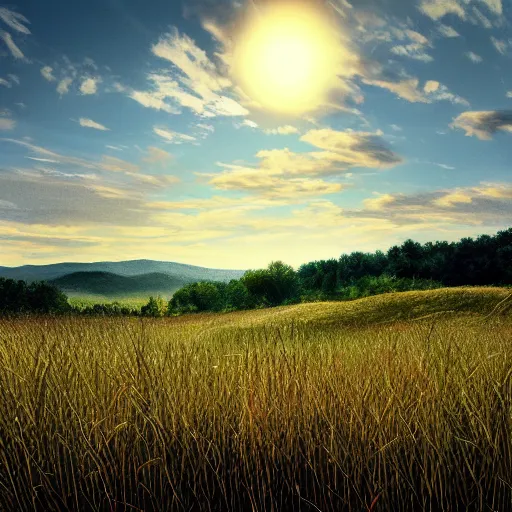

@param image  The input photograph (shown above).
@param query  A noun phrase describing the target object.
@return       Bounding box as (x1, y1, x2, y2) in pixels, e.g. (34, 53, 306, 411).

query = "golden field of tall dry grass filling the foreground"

(0, 288, 512, 512)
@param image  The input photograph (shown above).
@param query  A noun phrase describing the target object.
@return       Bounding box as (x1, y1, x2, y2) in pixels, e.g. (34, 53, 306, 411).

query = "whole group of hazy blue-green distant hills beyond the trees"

(0, 260, 244, 298)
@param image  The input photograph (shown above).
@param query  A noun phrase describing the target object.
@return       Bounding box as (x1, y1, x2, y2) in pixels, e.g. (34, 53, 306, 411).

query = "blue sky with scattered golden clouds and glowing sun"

(0, 0, 512, 269)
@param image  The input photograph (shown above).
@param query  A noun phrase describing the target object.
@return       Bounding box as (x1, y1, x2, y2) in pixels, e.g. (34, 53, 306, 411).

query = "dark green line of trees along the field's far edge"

(0, 228, 512, 317)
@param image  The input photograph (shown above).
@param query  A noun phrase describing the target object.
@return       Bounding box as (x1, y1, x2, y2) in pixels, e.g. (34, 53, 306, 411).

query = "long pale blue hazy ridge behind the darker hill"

(0, 260, 244, 283)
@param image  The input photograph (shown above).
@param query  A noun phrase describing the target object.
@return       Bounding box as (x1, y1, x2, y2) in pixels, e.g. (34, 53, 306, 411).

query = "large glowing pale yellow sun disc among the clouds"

(234, 2, 338, 114)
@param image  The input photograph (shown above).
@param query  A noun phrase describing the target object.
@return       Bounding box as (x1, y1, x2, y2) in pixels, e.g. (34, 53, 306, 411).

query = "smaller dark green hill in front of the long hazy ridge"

(50, 272, 187, 298)
